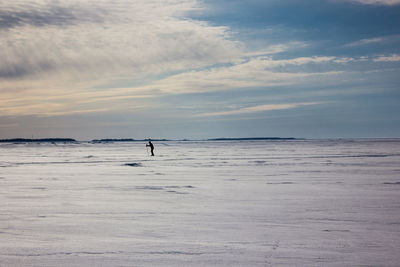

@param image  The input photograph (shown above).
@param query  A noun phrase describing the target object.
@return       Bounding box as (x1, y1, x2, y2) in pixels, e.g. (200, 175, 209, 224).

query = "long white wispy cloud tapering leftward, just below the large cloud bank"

(130, 57, 342, 94)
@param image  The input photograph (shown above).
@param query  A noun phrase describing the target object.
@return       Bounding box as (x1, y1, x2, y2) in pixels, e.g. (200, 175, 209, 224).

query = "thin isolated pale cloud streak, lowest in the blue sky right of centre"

(195, 102, 321, 117)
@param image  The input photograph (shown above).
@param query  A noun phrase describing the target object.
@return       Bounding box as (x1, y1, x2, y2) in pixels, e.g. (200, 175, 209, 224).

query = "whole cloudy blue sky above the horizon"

(0, 0, 400, 140)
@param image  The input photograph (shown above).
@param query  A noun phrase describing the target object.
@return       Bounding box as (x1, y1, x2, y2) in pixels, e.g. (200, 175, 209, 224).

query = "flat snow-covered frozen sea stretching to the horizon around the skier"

(0, 139, 400, 266)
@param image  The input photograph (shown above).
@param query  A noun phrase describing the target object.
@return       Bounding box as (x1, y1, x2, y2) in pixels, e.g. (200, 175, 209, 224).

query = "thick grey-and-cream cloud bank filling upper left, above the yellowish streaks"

(0, 0, 240, 82)
